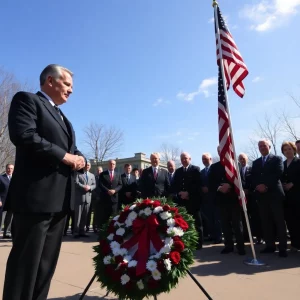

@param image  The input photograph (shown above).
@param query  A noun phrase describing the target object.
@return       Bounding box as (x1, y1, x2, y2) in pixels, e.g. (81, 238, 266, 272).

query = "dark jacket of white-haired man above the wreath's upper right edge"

(171, 165, 201, 210)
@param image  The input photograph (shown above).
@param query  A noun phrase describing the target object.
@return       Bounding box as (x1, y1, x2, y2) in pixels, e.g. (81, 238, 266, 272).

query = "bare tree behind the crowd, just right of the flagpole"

(256, 114, 282, 155)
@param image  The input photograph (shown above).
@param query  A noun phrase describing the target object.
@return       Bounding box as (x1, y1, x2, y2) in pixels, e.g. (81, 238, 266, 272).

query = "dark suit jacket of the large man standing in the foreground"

(6, 92, 82, 213)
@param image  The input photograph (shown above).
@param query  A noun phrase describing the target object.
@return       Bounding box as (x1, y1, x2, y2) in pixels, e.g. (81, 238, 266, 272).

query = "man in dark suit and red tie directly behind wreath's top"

(139, 153, 170, 199)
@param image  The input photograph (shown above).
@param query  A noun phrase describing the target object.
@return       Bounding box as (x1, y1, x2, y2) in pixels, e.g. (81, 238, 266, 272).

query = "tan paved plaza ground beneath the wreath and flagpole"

(0, 234, 300, 300)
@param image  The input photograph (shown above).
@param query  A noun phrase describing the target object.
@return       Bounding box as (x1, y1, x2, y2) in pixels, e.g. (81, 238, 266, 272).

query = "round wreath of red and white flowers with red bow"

(94, 198, 198, 300)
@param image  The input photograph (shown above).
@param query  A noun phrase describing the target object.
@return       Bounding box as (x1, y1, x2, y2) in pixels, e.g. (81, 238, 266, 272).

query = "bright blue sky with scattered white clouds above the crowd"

(0, 0, 300, 164)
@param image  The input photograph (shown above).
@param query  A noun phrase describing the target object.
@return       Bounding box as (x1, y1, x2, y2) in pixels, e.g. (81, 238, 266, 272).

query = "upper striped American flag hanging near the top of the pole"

(215, 7, 248, 97)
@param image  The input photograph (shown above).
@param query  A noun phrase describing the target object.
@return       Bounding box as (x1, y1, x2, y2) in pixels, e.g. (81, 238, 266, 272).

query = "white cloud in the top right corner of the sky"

(240, 0, 300, 32)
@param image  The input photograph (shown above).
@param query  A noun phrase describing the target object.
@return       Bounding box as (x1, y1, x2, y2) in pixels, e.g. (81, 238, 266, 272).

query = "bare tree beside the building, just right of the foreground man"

(83, 122, 124, 162)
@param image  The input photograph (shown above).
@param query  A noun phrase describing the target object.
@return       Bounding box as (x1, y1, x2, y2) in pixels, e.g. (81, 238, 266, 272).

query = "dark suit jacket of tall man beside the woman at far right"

(251, 154, 284, 201)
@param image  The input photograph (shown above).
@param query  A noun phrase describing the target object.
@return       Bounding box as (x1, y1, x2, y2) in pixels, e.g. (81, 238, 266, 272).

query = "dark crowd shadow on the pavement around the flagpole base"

(190, 245, 300, 276)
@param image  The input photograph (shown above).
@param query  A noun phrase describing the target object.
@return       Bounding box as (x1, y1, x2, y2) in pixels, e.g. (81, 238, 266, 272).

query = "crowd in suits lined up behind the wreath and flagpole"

(59, 140, 300, 257)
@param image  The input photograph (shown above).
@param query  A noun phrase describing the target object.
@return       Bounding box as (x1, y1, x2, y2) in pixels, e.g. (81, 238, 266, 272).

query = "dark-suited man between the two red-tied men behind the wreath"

(119, 164, 137, 208)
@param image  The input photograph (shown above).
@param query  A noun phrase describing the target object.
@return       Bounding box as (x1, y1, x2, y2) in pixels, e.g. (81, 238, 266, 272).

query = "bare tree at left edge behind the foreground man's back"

(0, 67, 32, 172)
